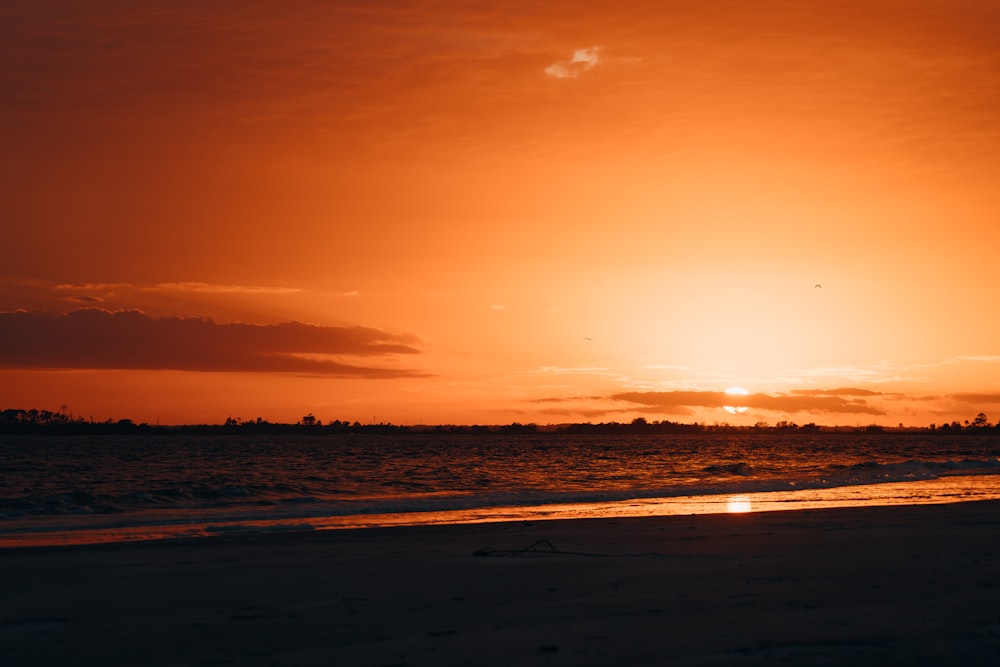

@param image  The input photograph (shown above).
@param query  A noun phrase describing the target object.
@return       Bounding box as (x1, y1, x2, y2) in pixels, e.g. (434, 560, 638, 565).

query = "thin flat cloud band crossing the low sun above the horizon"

(609, 389, 886, 415)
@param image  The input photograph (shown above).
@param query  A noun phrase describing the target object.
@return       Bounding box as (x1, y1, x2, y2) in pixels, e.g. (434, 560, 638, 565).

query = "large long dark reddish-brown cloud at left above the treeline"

(0, 308, 424, 377)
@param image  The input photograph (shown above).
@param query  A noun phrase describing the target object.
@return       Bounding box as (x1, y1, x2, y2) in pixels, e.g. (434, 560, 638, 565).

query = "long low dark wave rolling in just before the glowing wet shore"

(0, 458, 1000, 520)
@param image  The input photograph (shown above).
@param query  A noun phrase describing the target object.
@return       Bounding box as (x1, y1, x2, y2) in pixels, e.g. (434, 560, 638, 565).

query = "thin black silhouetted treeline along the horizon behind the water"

(0, 410, 1000, 436)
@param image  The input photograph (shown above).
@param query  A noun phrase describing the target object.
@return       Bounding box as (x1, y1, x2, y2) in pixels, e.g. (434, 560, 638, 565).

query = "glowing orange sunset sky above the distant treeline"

(0, 0, 1000, 426)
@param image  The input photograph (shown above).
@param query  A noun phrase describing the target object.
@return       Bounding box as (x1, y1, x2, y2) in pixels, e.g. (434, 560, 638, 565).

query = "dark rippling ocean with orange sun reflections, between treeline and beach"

(0, 429, 1000, 547)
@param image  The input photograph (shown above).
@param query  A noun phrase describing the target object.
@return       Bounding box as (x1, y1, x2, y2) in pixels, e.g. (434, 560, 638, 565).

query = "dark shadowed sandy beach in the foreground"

(0, 502, 1000, 667)
